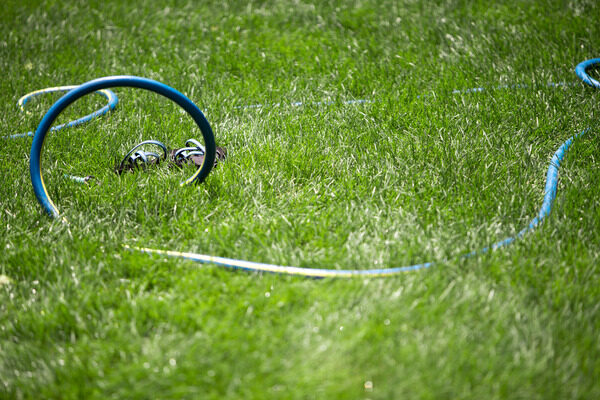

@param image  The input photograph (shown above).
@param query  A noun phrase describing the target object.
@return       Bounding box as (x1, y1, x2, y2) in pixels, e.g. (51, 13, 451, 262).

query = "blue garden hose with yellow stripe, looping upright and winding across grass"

(19, 58, 600, 278)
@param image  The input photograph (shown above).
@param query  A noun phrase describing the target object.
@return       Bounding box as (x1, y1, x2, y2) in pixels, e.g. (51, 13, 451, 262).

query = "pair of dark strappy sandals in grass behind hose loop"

(115, 139, 227, 175)
